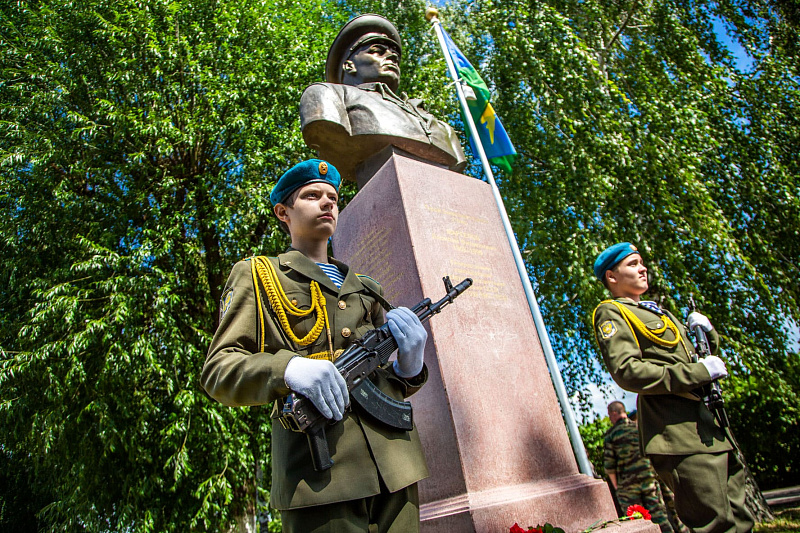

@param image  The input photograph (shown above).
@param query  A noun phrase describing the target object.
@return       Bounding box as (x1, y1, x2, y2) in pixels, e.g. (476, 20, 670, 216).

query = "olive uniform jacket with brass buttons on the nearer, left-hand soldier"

(201, 250, 428, 510)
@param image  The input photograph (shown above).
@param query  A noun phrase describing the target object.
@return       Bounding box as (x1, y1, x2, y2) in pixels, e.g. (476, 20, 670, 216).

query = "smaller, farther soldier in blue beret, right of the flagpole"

(593, 242, 754, 533)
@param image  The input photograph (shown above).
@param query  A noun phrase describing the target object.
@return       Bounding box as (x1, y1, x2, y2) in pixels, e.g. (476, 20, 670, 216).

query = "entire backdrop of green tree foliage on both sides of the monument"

(0, 0, 800, 532)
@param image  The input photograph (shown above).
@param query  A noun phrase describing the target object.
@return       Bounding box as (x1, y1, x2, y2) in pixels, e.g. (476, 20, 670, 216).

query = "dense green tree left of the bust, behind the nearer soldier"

(0, 0, 343, 531)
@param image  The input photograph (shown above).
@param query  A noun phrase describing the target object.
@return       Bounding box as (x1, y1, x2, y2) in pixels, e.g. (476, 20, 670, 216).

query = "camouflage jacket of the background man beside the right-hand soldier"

(603, 418, 656, 485)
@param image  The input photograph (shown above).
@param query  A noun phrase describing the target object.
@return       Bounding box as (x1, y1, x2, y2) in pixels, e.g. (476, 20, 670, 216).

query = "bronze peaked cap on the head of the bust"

(325, 14, 403, 83)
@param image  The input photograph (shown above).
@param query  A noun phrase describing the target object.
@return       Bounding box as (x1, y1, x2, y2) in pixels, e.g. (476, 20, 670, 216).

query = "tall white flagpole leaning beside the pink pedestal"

(425, 7, 593, 476)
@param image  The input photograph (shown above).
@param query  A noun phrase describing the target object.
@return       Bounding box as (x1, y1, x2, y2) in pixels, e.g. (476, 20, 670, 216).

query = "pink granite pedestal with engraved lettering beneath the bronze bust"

(333, 150, 658, 533)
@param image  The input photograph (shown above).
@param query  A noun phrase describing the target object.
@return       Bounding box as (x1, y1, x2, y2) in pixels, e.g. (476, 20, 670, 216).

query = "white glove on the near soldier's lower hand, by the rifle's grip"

(283, 356, 350, 420)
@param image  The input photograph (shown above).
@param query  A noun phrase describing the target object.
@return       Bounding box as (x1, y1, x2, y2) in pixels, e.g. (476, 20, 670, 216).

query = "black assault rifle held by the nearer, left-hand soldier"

(283, 276, 472, 472)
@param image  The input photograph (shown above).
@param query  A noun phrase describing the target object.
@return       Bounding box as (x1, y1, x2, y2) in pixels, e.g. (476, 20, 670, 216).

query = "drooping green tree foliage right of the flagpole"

(442, 0, 800, 483)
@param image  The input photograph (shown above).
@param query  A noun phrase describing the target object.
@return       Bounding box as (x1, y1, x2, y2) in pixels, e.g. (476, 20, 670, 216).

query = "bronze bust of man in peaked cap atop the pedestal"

(300, 14, 466, 180)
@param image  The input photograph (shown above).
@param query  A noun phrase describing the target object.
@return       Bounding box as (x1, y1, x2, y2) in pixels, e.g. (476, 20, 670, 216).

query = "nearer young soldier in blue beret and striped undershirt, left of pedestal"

(201, 159, 428, 533)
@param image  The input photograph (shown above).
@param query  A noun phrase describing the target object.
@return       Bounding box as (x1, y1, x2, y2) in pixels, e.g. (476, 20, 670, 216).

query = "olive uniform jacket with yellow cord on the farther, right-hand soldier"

(593, 298, 732, 455)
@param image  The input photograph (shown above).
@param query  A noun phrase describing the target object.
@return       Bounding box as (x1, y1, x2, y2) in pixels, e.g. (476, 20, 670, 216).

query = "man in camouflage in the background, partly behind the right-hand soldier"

(603, 402, 674, 533)
